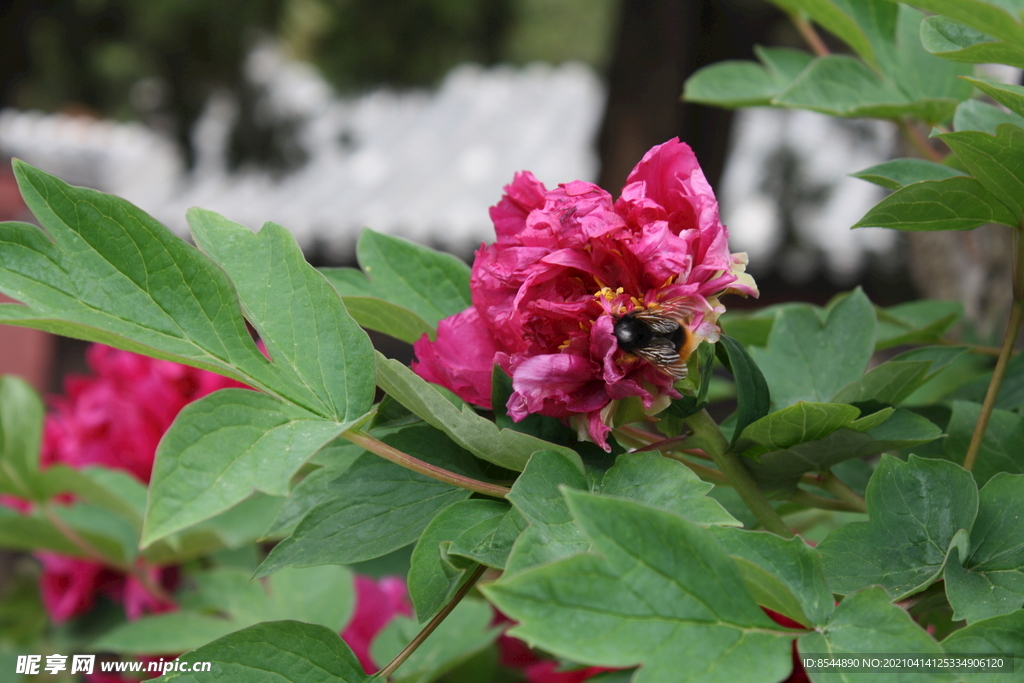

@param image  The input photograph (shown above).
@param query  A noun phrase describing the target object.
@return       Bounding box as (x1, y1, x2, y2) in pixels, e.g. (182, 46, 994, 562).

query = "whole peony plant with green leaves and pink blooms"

(0, 0, 1024, 683)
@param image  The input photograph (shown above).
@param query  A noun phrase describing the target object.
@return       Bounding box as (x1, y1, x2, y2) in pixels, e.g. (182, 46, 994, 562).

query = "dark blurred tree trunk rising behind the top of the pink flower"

(598, 0, 781, 195)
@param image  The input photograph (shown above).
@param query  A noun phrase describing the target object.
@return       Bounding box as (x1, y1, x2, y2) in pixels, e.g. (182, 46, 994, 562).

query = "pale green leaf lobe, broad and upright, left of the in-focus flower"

(187, 209, 374, 423)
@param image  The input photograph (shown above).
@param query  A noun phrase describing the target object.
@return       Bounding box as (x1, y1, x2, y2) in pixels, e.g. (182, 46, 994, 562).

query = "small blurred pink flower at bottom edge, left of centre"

(341, 577, 413, 674)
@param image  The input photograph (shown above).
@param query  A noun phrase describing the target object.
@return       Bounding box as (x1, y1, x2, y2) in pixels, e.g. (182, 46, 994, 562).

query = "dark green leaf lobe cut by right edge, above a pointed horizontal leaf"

(938, 124, 1024, 222)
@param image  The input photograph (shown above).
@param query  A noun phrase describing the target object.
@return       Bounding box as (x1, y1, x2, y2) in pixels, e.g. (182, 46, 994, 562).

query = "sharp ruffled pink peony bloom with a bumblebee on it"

(413, 139, 758, 450)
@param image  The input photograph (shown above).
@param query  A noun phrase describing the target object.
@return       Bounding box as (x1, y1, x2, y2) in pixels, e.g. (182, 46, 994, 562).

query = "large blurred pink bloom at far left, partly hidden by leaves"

(0, 344, 247, 624)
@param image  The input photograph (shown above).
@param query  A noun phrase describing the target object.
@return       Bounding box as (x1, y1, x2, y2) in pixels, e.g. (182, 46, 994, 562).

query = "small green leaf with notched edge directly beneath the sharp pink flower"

(505, 451, 590, 573)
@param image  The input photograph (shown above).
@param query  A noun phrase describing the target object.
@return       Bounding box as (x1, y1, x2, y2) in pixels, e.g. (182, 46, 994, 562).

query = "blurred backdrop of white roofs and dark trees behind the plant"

(0, 0, 937, 392)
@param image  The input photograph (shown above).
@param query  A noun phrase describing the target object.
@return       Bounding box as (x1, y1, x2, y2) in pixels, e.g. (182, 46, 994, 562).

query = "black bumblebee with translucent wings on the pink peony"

(613, 305, 697, 380)
